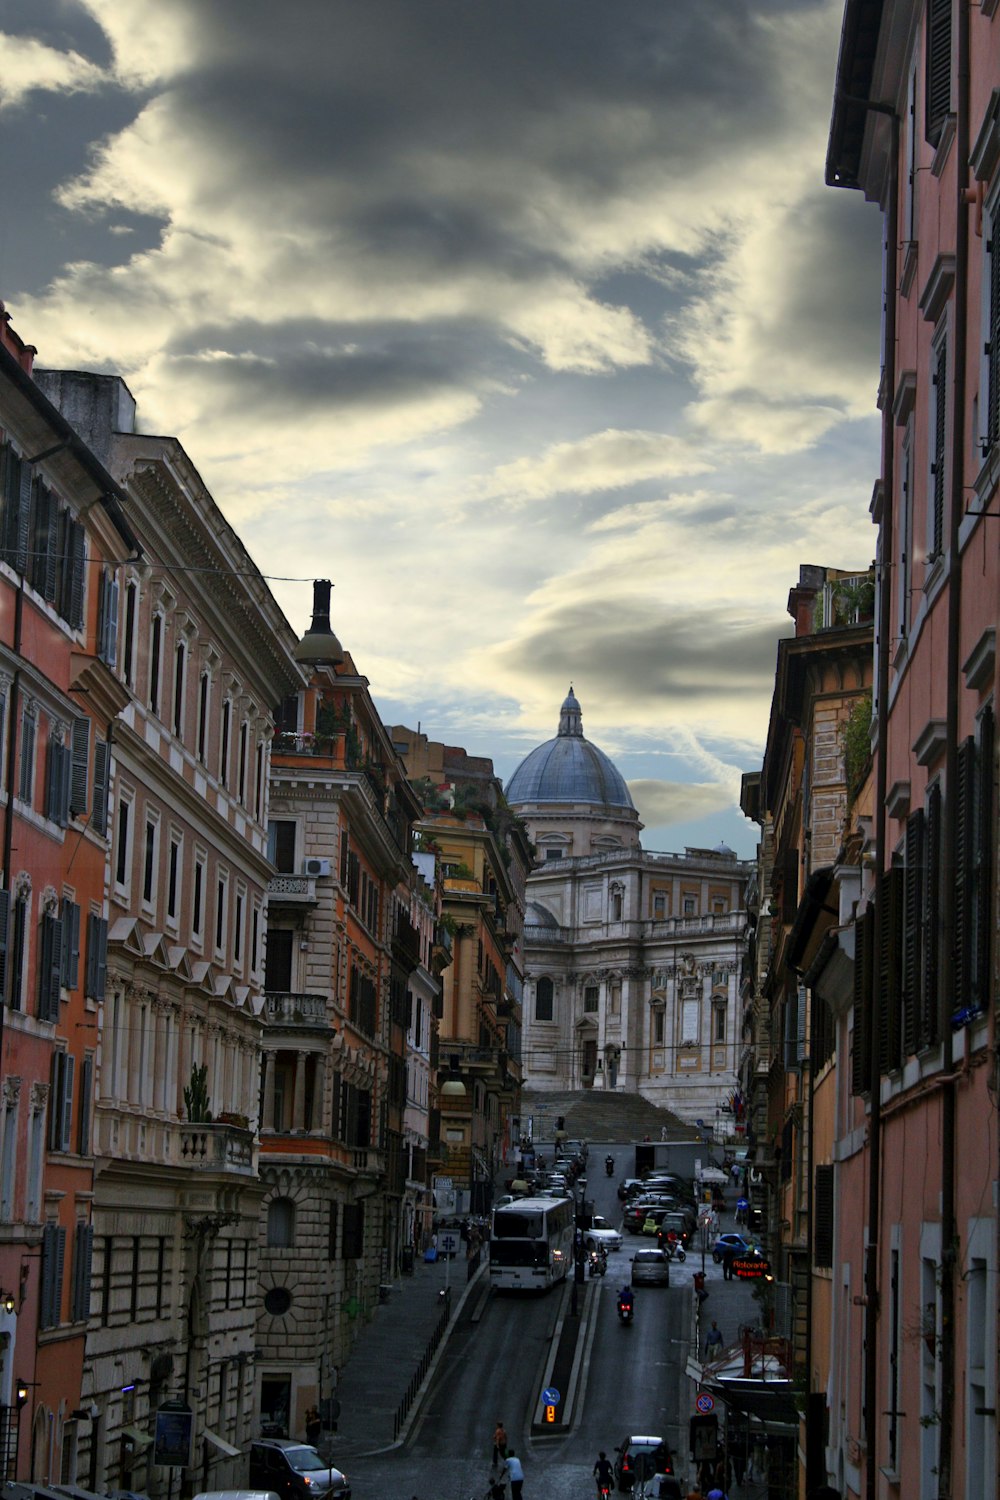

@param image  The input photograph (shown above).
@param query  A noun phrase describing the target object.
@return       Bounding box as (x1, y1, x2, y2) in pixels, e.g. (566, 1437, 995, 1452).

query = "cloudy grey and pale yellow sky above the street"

(0, 0, 880, 854)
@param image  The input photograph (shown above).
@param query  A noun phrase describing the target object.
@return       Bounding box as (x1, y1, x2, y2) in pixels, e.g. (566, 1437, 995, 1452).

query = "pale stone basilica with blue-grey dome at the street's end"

(507, 689, 751, 1122)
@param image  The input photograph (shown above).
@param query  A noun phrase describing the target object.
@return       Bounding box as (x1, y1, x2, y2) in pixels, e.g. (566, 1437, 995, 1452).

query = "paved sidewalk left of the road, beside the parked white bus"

(328, 1254, 478, 1464)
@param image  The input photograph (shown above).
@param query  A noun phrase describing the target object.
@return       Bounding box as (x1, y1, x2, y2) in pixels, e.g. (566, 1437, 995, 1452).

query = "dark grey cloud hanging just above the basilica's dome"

(501, 600, 784, 702)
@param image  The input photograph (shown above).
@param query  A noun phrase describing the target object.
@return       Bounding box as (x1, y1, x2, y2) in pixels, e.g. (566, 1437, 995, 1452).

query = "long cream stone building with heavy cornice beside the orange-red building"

(36, 371, 303, 1496)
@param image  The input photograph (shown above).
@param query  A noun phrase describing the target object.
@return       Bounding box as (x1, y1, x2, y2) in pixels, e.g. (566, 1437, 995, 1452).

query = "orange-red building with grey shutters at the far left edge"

(0, 308, 141, 1481)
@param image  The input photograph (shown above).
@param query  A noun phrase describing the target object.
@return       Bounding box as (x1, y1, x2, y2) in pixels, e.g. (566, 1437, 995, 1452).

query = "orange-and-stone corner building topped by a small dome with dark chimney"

(256, 582, 425, 1434)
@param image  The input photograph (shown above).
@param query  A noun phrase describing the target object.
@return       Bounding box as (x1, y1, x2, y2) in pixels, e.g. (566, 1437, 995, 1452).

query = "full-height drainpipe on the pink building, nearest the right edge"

(937, 5, 969, 1500)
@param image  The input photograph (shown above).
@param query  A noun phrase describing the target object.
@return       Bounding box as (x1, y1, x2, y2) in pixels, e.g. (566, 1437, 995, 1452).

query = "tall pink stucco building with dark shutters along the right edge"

(826, 0, 1000, 1500)
